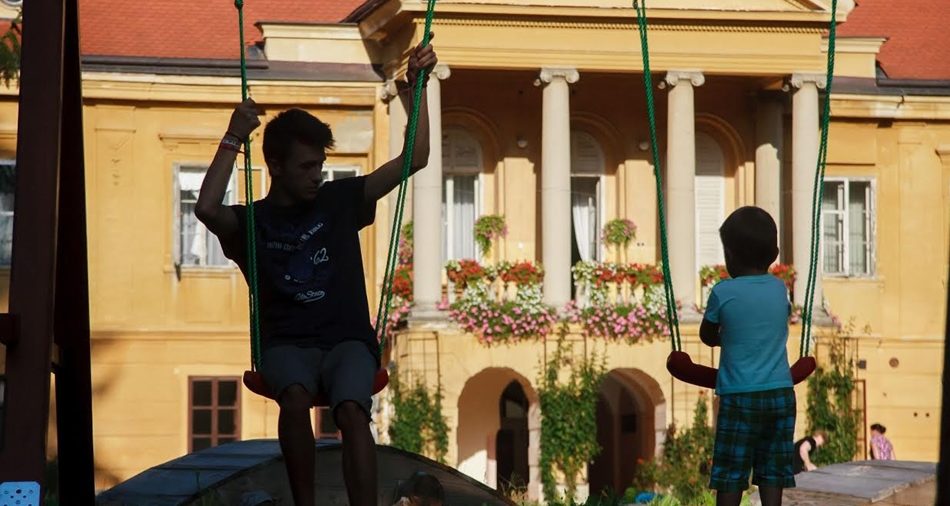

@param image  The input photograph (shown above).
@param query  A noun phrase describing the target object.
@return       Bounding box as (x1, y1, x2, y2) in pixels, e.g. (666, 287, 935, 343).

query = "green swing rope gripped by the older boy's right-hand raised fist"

(376, 0, 436, 349)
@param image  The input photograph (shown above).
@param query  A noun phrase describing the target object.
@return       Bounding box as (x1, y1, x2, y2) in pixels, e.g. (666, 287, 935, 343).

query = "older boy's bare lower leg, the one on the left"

(277, 385, 316, 506)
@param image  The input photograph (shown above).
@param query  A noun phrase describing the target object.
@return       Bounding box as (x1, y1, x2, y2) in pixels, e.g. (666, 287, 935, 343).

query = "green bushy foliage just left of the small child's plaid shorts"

(634, 392, 715, 504)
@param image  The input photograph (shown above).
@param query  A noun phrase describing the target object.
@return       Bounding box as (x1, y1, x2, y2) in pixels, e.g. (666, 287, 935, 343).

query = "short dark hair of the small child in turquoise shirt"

(719, 206, 778, 270)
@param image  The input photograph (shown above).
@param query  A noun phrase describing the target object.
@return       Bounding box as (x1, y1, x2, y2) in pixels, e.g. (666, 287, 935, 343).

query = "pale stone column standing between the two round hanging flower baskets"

(539, 68, 580, 310)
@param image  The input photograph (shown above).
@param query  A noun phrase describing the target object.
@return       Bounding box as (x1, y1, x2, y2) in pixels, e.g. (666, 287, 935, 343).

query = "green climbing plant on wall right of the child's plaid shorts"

(807, 333, 858, 466)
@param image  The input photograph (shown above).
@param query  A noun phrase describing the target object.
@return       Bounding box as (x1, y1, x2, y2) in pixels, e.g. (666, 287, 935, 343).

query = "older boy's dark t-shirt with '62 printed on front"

(221, 177, 379, 361)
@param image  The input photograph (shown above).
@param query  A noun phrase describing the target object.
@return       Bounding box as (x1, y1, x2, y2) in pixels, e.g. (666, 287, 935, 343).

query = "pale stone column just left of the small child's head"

(664, 70, 705, 319)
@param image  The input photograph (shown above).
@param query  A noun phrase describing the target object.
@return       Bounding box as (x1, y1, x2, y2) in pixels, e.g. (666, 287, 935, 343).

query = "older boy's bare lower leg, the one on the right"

(334, 401, 378, 506)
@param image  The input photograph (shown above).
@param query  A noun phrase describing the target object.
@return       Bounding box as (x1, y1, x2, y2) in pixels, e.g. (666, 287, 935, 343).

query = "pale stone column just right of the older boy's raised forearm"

(412, 64, 451, 320)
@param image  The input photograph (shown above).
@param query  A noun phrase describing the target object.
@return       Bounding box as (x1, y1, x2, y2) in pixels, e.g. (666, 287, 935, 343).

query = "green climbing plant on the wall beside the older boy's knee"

(389, 373, 449, 464)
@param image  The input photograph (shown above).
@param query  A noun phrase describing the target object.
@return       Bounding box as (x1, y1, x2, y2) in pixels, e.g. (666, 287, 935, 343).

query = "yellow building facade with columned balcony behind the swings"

(0, 0, 950, 497)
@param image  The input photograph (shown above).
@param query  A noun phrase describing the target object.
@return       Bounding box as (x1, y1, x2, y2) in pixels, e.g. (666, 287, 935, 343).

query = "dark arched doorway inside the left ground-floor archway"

(495, 381, 529, 490)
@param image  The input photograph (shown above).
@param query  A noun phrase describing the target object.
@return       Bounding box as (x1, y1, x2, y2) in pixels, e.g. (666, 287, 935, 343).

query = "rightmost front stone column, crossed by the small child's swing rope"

(790, 74, 826, 313)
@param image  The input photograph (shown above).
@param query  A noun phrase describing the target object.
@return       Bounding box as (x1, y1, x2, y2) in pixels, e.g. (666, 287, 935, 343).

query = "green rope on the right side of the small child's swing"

(800, 0, 838, 357)
